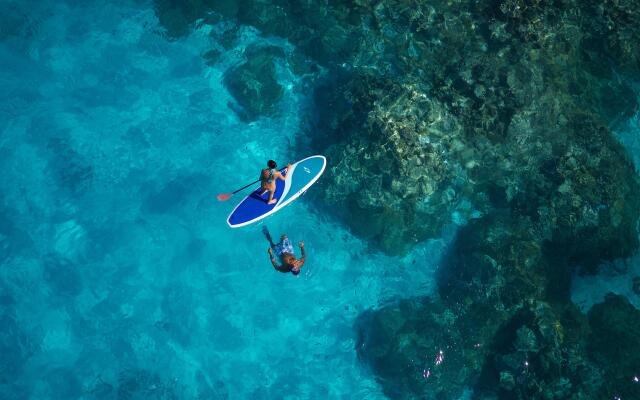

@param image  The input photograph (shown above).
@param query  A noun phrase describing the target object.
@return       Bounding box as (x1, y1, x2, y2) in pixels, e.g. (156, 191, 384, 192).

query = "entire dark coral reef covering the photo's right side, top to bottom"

(150, 0, 640, 399)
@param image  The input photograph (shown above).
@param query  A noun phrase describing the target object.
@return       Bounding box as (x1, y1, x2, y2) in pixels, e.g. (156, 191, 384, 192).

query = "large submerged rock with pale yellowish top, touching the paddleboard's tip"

(315, 72, 473, 254)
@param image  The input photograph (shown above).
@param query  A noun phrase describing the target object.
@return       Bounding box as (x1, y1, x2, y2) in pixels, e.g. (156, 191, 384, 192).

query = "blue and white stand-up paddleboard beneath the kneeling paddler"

(227, 156, 327, 228)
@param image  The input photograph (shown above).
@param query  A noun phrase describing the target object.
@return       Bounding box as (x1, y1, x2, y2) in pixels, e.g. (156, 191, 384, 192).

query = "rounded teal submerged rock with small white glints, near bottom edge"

(356, 298, 485, 399)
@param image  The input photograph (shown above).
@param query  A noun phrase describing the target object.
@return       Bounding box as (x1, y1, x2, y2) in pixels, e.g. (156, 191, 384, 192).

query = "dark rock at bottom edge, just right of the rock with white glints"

(476, 302, 603, 399)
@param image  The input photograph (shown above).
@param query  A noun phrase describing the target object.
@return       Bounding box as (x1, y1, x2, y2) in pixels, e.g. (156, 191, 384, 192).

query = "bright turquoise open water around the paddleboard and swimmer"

(0, 1, 450, 399)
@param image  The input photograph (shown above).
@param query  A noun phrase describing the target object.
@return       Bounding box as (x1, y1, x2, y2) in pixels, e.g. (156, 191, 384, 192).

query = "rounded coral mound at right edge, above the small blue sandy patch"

(484, 100, 640, 272)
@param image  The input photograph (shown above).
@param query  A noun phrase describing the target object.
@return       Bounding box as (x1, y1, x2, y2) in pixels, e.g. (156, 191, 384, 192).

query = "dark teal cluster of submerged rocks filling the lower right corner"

(356, 213, 638, 399)
